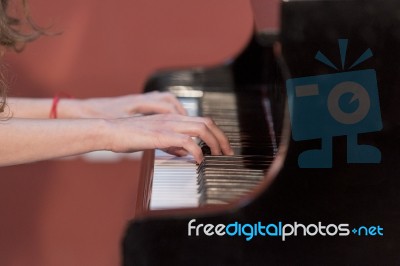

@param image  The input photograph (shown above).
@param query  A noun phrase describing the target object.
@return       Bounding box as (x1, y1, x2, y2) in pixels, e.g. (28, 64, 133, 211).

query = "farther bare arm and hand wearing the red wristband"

(7, 92, 186, 118)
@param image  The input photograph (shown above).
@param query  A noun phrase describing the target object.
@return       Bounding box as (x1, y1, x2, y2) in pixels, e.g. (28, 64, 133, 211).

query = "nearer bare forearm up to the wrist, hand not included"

(0, 118, 107, 166)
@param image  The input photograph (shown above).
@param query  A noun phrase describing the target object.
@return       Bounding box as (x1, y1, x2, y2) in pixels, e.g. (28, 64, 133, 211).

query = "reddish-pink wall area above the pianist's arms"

(6, 0, 253, 97)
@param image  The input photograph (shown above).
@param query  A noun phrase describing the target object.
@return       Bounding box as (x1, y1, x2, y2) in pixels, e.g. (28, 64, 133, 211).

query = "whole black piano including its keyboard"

(122, 0, 400, 265)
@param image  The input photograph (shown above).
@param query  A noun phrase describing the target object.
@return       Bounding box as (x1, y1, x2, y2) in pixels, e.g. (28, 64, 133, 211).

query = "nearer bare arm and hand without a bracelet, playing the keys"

(0, 114, 233, 166)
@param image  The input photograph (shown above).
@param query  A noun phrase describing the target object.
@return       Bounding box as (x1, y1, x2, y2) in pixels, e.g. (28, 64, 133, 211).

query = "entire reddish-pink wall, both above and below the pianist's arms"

(0, 0, 278, 266)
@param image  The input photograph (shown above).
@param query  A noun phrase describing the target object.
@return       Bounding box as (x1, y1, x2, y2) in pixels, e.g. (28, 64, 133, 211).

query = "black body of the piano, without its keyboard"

(122, 0, 400, 265)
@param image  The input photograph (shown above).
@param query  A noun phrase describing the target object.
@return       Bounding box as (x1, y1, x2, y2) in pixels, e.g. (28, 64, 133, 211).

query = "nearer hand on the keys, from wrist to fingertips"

(107, 114, 233, 163)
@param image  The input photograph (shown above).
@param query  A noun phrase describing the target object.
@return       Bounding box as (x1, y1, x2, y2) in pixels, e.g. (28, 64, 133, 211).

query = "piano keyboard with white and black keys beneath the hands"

(149, 92, 276, 210)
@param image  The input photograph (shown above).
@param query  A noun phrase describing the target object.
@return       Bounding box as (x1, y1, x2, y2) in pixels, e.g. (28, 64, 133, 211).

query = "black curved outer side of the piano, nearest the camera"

(124, 0, 400, 265)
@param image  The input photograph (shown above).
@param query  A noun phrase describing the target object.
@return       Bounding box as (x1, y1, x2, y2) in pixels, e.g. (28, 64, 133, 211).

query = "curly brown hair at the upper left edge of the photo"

(0, 0, 44, 113)
